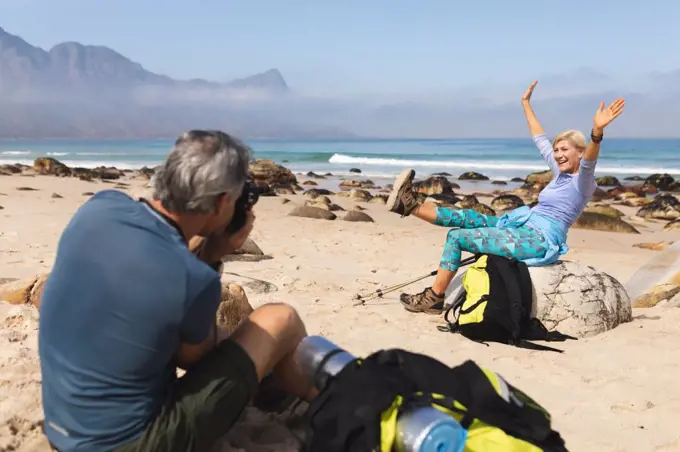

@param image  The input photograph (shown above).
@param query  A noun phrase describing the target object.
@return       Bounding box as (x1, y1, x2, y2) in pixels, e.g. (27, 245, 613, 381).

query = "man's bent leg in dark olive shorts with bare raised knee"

(116, 304, 316, 452)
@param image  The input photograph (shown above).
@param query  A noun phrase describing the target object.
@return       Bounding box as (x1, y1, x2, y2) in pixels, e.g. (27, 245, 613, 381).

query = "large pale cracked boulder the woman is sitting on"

(529, 261, 632, 337)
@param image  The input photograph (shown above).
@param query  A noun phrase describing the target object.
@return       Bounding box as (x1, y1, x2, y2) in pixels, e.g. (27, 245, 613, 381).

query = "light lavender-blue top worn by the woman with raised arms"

(532, 134, 597, 233)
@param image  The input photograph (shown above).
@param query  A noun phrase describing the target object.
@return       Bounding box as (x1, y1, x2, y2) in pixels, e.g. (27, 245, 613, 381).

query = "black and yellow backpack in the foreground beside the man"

(304, 349, 567, 452)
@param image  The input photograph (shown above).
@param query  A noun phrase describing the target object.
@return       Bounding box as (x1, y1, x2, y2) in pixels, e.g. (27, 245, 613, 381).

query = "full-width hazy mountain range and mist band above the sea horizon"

(0, 28, 680, 139)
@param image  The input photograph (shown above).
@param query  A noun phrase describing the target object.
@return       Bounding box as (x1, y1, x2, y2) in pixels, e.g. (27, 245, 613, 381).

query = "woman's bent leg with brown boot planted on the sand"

(401, 226, 547, 314)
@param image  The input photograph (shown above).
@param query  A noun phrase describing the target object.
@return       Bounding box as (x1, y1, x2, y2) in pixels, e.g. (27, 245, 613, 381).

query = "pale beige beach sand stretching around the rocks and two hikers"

(0, 176, 680, 452)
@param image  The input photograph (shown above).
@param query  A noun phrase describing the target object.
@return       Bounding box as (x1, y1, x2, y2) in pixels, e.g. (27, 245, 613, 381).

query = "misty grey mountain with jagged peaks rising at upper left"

(0, 28, 354, 139)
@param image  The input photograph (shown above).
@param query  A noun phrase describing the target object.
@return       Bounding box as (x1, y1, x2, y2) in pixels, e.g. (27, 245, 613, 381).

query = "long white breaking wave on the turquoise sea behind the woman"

(328, 154, 680, 174)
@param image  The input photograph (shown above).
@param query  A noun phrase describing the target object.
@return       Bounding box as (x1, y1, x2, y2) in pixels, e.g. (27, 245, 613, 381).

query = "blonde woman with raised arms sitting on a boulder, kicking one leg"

(387, 82, 625, 314)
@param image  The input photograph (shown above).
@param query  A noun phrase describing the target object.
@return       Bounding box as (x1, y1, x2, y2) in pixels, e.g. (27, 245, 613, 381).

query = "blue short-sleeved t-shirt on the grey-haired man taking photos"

(39, 190, 221, 451)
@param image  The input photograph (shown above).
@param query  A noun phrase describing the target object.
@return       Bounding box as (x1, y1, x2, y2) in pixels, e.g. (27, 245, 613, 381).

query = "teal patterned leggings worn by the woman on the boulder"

(434, 207, 547, 271)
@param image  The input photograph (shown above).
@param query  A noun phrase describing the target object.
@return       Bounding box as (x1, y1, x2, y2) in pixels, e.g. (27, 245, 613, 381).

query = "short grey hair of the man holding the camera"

(153, 130, 250, 213)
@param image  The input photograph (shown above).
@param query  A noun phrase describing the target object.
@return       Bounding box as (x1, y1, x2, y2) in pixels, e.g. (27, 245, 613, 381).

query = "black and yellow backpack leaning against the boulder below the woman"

(439, 254, 576, 353)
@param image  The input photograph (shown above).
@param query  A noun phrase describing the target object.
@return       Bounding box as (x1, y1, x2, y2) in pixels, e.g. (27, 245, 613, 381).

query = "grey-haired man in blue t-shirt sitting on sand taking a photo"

(39, 131, 309, 451)
